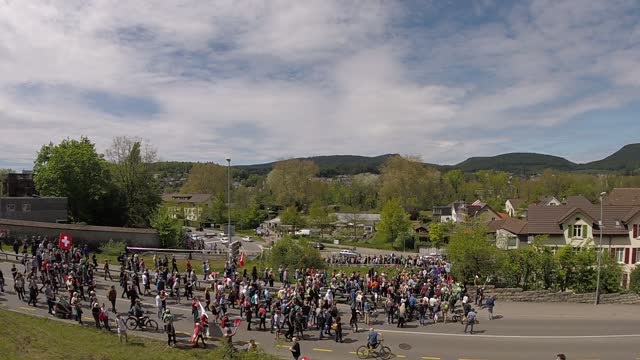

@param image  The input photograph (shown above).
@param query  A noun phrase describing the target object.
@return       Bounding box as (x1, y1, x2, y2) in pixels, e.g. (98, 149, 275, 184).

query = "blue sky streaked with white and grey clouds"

(0, 0, 640, 170)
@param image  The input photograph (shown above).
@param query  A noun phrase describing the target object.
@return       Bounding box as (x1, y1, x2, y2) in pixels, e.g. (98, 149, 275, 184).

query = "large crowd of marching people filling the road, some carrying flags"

(0, 237, 495, 358)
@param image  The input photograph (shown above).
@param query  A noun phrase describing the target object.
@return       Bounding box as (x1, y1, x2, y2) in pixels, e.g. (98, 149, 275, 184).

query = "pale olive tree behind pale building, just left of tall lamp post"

(180, 163, 228, 195)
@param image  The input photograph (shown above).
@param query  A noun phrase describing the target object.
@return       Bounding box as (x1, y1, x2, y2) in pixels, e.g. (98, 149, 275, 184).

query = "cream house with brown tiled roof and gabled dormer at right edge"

(527, 199, 640, 286)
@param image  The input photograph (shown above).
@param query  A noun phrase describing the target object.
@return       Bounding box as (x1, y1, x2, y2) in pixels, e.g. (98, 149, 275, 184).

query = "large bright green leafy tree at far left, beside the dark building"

(33, 137, 123, 225)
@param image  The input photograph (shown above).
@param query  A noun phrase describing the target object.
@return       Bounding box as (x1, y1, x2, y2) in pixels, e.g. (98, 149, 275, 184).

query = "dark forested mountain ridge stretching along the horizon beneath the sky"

(154, 143, 640, 177)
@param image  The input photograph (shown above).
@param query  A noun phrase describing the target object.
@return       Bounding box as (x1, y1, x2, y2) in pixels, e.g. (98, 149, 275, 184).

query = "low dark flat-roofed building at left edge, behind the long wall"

(0, 196, 68, 223)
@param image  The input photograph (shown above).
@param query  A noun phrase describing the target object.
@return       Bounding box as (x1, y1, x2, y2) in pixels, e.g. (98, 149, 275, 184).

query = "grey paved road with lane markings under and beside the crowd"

(0, 263, 640, 360)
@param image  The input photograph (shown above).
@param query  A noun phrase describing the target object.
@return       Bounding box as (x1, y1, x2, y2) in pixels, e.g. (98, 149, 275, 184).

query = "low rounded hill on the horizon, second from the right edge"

(453, 153, 577, 174)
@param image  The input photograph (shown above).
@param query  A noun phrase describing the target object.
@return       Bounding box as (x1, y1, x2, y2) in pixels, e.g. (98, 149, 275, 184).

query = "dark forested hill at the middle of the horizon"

(236, 154, 397, 177)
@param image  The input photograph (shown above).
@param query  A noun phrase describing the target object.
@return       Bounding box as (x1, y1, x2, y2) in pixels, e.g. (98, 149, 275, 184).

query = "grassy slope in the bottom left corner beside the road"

(0, 310, 277, 360)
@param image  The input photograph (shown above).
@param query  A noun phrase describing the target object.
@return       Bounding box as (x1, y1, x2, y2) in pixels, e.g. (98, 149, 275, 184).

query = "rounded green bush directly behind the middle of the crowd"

(267, 236, 326, 269)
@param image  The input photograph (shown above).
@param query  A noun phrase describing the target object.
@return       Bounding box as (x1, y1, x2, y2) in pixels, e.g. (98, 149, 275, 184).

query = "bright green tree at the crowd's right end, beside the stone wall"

(447, 222, 498, 283)
